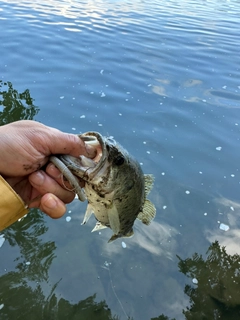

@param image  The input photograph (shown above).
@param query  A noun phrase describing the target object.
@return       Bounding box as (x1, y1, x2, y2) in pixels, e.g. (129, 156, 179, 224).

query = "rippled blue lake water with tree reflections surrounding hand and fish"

(0, 0, 240, 320)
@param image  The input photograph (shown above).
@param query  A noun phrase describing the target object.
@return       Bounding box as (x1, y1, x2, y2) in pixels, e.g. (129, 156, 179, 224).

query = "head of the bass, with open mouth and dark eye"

(60, 131, 143, 195)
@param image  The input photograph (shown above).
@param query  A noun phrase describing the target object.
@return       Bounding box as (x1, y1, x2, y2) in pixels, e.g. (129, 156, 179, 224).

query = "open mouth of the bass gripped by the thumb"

(59, 131, 108, 181)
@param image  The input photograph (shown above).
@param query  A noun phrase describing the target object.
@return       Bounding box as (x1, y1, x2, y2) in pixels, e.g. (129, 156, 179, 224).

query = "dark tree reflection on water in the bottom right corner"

(178, 241, 240, 320)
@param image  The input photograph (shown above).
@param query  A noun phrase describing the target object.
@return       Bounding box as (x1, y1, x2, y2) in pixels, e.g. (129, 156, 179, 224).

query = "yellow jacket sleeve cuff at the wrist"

(0, 176, 29, 231)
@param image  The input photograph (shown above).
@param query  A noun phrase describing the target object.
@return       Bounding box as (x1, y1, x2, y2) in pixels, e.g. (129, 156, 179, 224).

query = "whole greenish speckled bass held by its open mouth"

(51, 131, 156, 242)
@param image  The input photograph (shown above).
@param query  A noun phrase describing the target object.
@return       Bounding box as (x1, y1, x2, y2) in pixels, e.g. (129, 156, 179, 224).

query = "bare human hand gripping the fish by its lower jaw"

(0, 120, 95, 218)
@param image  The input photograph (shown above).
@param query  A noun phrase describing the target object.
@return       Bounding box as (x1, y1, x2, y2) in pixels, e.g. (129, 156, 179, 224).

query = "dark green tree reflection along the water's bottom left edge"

(0, 280, 118, 320)
